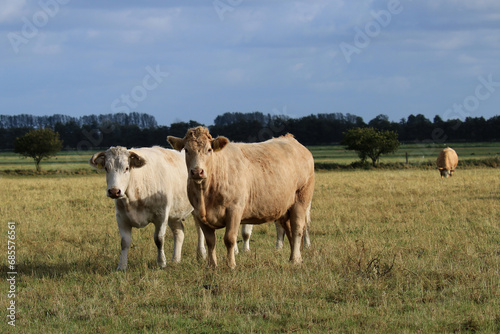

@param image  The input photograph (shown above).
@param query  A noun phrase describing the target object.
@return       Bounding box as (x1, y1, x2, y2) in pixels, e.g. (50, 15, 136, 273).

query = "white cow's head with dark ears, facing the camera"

(89, 146, 146, 198)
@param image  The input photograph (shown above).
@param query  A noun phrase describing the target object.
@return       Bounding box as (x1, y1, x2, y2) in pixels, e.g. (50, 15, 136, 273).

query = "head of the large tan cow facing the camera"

(167, 126, 229, 184)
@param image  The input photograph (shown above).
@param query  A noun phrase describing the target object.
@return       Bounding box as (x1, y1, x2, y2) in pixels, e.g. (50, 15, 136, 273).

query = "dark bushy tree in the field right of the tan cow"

(340, 128, 399, 166)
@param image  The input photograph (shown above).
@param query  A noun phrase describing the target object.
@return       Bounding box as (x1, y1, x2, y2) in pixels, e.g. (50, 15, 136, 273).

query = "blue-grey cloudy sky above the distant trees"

(0, 0, 500, 125)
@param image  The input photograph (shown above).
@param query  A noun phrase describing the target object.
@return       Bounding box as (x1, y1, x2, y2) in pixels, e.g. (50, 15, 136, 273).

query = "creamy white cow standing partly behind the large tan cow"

(89, 146, 206, 270)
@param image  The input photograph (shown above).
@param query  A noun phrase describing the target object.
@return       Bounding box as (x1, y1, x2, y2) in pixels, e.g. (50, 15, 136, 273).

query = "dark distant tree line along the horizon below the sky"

(0, 112, 500, 150)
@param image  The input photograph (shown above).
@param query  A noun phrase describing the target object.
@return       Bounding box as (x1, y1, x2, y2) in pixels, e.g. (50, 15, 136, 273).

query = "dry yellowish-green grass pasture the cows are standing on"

(0, 167, 500, 333)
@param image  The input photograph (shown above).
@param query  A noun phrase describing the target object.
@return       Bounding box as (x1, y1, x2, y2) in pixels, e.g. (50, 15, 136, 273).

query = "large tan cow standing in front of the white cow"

(168, 127, 314, 268)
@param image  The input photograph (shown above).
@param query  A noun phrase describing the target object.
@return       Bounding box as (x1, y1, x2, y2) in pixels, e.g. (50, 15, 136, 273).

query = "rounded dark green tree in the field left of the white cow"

(14, 128, 63, 172)
